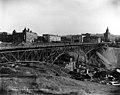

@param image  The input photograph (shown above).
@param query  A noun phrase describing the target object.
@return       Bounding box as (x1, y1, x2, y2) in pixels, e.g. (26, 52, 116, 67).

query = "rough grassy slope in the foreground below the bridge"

(0, 63, 119, 95)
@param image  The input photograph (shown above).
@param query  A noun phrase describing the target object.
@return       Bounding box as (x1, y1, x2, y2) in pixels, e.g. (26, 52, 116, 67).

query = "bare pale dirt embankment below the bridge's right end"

(87, 46, 120, 70)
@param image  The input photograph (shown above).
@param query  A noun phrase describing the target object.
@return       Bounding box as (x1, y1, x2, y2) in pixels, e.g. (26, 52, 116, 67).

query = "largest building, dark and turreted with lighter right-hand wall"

(12, 28, 37, 44)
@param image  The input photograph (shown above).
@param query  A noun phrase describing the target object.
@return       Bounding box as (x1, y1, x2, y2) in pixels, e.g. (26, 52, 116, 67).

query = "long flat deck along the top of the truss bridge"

(0, 43, 104, 51)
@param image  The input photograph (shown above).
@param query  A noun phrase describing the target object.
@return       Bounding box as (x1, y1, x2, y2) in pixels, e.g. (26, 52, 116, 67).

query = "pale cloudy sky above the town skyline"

(0, 0, 120, 35)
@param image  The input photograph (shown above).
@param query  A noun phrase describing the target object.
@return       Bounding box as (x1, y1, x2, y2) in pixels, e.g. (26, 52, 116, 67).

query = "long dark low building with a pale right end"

(83, 36, 101, 43)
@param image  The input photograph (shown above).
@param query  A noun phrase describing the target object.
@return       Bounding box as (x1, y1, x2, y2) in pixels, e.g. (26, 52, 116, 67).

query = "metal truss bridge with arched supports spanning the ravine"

(0, 43, 105, 65)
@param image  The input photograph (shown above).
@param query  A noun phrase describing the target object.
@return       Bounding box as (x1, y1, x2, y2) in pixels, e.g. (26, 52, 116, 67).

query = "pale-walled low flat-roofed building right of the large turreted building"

(43, 34, 61, 42)
